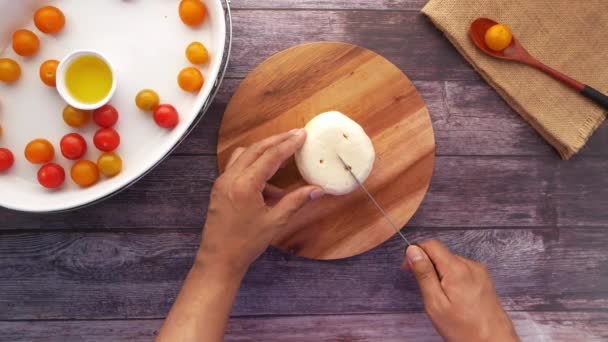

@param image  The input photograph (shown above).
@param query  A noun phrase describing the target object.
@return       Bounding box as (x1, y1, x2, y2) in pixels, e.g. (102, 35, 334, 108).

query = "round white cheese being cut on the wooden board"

(295, 112, 376, 195)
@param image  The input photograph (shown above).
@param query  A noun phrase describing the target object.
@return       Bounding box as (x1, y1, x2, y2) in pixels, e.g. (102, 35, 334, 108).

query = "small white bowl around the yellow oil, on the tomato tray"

(56, 50, 118, 110)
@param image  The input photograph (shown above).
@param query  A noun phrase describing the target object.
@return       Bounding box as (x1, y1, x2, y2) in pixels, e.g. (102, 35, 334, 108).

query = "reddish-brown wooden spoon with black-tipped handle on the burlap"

(469, 18, 608, 109)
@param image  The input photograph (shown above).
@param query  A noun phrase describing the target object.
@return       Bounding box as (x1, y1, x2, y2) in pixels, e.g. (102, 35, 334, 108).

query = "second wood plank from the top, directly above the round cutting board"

(227, 10, 479, 80)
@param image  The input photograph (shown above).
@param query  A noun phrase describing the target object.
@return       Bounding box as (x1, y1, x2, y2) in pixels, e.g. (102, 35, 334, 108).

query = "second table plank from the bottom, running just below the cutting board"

(0, 228, 608, 320)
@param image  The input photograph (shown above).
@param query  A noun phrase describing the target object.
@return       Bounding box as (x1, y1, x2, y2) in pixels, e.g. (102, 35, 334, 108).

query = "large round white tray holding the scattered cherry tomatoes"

(0, 0, 229, 212)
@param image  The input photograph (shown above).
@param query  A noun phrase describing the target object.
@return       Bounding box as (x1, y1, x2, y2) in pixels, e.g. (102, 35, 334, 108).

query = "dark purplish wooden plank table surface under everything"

(0, 0, 608, 341)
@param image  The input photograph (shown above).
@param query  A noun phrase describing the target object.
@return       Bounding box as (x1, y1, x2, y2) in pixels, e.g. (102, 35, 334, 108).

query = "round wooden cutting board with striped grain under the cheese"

(218, 43, 435, 259)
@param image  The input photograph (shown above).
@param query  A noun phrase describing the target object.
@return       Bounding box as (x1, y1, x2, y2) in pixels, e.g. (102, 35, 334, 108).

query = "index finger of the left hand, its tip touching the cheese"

(248, 129, 306, 184)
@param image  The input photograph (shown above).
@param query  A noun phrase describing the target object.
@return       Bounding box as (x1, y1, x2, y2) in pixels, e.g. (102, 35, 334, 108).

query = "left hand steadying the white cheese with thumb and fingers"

(197, 129, 324, 274)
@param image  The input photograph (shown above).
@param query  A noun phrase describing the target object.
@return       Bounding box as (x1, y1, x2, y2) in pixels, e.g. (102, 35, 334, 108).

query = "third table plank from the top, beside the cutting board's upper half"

(176, 79, 608, 156)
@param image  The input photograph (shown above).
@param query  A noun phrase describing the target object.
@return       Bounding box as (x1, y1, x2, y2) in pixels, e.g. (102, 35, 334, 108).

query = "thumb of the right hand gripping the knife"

(405, 245, 447, 303)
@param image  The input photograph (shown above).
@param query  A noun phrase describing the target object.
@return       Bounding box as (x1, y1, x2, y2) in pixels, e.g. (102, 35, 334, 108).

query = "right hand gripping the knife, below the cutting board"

(402, 241, 519, 341)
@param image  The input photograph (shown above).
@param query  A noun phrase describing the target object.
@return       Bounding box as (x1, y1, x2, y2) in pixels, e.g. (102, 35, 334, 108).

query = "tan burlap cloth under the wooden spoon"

(422, 0, 608, 159)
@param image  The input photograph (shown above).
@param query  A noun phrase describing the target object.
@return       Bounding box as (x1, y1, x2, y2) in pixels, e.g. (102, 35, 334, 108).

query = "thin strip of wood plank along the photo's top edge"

(231, 0, 428, 11)
